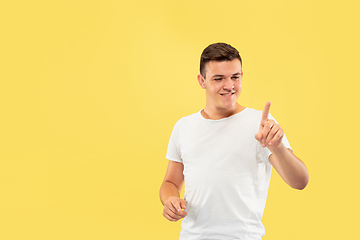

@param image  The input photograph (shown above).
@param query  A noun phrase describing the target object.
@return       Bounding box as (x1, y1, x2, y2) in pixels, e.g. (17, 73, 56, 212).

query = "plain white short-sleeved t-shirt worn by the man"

(166, 108, 290, 240)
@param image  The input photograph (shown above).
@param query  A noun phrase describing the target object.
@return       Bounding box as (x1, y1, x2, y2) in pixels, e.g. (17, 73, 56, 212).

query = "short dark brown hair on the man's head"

(200, 42, 242, 78)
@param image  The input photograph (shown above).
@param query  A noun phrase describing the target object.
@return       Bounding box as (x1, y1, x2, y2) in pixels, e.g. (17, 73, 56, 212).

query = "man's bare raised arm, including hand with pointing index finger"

(255, 102, 309, 190)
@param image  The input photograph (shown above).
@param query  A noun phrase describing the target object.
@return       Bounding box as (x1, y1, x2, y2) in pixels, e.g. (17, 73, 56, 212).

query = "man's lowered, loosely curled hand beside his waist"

(163, 197, 187, 222)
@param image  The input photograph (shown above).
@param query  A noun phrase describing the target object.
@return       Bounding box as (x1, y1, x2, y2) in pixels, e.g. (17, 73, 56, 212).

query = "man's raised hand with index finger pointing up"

(255, 102, 284, 151)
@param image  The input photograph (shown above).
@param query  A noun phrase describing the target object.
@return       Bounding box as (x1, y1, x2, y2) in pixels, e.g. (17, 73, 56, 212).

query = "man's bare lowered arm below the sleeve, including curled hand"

(160, 161, 187, 222)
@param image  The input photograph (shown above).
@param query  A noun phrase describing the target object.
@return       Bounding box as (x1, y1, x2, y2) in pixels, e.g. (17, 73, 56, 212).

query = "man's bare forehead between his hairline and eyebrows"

(205, 58, 241, 75)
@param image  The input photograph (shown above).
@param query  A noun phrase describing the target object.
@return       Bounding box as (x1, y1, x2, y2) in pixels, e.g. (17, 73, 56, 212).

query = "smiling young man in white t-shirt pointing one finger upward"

(160, 43, 309, 240)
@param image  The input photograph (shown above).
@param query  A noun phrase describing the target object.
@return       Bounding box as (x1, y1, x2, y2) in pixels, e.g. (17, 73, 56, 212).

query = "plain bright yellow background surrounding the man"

(0, 0, 360, 240)
